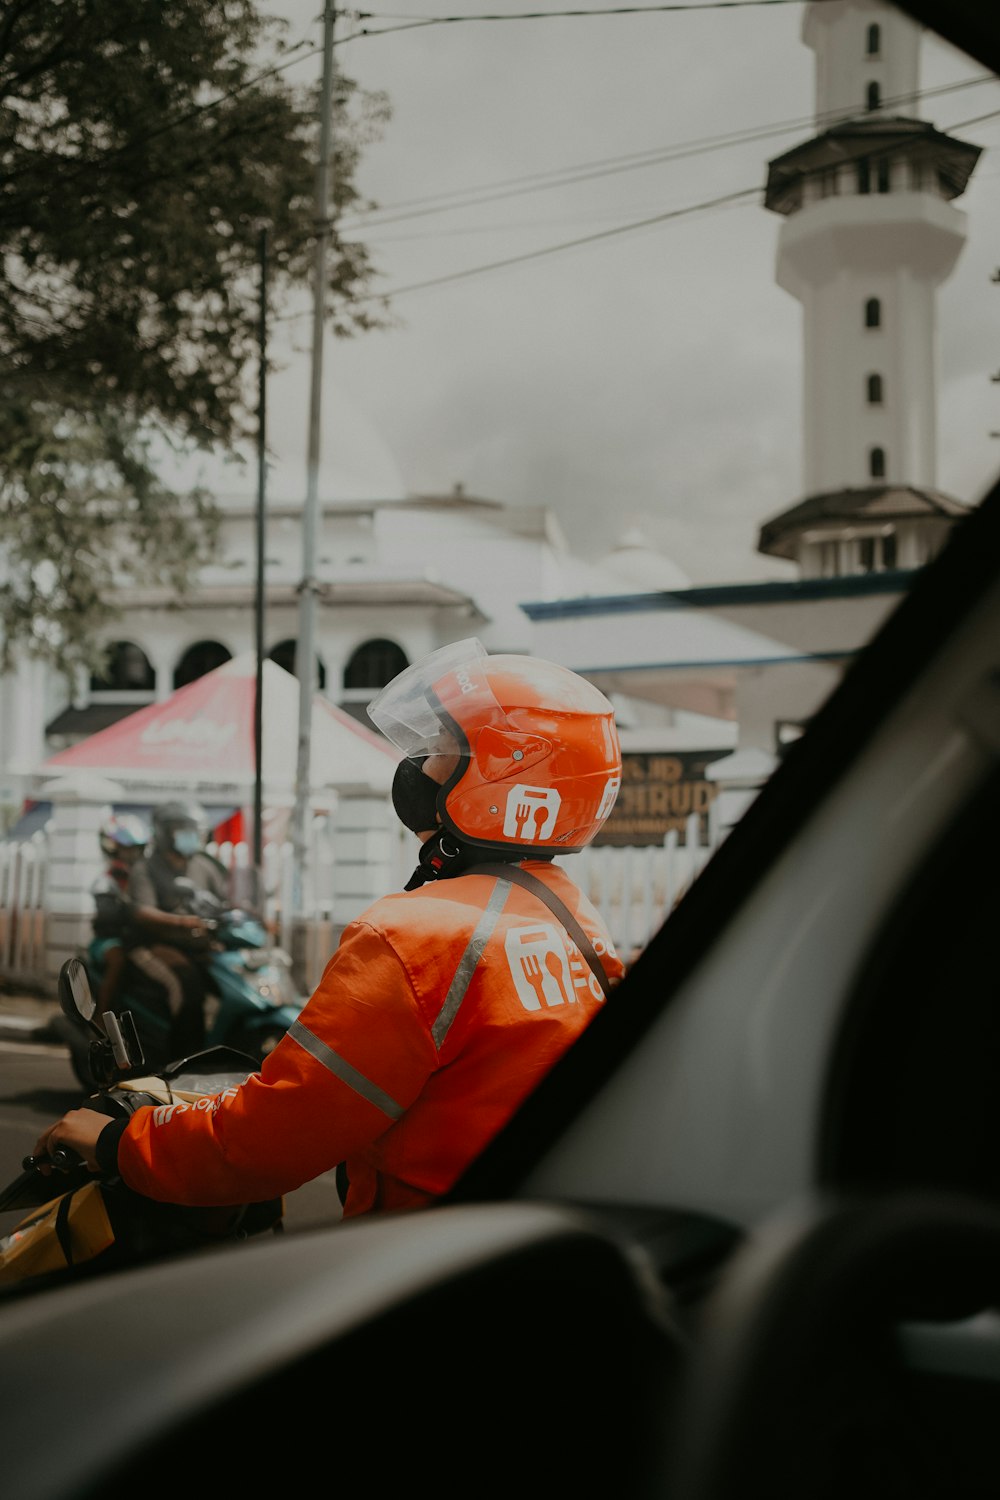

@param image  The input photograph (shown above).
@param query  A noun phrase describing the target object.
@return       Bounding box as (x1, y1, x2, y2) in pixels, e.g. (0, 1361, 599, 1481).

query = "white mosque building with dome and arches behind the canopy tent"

(0, 363, 685, 834)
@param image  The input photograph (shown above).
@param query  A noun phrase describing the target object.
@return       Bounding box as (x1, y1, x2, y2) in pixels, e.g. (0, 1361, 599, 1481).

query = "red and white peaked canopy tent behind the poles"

(25, 653, 399, 842)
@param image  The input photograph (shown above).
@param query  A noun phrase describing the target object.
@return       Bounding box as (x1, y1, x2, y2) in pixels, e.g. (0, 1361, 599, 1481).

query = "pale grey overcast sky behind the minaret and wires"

(245, 0, 1000, 584)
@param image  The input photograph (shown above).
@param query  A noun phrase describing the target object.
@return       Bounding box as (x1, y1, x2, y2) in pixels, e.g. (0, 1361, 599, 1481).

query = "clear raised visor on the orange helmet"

(367, 636, 502, 759)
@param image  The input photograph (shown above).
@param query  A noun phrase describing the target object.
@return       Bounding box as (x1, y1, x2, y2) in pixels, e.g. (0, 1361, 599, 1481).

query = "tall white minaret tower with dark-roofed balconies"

(760, 0, 981, 576)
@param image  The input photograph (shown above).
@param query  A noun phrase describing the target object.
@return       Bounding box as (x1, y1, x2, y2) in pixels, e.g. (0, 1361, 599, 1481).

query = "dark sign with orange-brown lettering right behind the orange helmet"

(594, 750, 727, 846)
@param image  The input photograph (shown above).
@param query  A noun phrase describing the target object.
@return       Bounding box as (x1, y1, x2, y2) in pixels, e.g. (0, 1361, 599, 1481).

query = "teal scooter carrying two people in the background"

(55, 882, 304, 1089)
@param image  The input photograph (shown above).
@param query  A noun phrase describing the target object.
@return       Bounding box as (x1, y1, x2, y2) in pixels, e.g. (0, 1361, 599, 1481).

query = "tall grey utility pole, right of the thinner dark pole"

(292, 0, 336, 918)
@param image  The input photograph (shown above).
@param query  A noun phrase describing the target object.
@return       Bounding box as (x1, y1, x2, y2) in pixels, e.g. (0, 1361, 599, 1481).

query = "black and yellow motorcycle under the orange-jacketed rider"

(0, 959, 285, 1293)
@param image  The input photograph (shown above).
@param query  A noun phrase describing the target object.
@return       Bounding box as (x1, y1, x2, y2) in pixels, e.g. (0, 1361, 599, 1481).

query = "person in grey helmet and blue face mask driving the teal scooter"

(129, 803, 229, 1056)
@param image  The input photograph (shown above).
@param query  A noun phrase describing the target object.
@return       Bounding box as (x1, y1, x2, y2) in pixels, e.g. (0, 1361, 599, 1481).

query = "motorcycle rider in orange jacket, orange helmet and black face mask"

(36, 639, 624, 1218)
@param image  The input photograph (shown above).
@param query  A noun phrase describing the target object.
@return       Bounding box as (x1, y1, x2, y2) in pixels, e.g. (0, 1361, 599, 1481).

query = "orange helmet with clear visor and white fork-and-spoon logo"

(369, 638, 622, 860)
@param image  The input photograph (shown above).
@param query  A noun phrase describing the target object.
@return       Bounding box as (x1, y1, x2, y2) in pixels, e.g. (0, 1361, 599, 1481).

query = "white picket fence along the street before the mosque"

(0, 815, 714, 987)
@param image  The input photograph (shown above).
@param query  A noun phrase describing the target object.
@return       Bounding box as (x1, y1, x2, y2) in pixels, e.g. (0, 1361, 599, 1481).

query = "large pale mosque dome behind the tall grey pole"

(156, 336, 406, 507)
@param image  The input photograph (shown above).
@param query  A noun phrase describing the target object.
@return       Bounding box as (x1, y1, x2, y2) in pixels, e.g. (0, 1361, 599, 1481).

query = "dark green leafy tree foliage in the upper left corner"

(0, 0, 387, 668)
